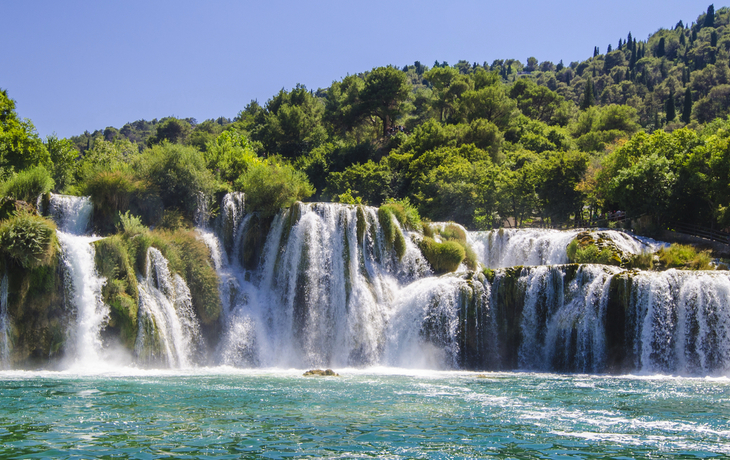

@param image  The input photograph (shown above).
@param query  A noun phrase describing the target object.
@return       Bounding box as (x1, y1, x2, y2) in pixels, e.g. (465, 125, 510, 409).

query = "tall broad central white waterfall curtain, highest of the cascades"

(200, 199, 436, 366)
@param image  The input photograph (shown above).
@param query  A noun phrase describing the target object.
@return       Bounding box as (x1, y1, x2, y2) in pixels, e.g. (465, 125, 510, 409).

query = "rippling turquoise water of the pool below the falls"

(0, 369, 730, 459)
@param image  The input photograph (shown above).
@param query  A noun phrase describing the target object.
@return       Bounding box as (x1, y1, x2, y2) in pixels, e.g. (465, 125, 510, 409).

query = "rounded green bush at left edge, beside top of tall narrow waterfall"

(0, 211, 58, 269)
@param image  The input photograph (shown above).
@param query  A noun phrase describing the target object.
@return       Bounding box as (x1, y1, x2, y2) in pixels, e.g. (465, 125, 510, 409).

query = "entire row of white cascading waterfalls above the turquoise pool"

(9, 189, 730, 375)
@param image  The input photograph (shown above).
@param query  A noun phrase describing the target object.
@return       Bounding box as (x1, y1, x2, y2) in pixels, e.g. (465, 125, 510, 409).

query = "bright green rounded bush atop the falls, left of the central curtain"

(235, 162, 314, 218)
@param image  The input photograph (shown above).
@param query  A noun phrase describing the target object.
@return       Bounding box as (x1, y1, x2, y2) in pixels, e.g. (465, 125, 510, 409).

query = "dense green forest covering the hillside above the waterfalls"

(0, 5, 730, 234)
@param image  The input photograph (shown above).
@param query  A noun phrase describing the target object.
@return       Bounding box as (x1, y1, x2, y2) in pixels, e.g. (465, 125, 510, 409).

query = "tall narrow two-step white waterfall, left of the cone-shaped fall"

(50, 194, 109, 367)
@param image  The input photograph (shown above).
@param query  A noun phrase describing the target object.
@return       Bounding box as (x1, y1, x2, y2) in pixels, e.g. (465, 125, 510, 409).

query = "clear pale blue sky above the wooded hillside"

(0, 0, 726, 137)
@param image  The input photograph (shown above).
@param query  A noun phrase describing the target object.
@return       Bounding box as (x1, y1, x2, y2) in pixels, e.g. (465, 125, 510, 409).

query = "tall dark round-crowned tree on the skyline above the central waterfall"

(360, 67, 411, 137)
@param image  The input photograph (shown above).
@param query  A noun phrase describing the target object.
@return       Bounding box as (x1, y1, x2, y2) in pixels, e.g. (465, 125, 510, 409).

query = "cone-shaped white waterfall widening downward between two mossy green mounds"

(135, 247, 203, 368)
